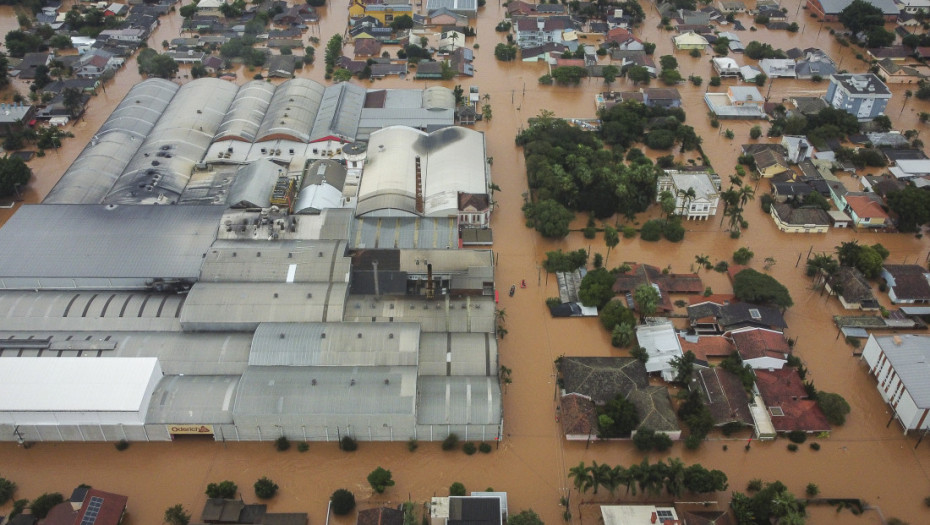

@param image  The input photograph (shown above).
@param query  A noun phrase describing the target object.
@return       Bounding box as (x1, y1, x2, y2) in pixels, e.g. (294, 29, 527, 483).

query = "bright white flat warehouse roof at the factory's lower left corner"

(0, 357, 161, 412)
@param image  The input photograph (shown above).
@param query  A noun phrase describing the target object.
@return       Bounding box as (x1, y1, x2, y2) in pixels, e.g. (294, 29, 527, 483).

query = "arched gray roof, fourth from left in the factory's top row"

(255, 78, 325, 143)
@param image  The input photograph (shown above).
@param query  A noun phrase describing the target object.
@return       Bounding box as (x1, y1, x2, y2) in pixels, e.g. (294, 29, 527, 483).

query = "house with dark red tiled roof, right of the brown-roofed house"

(755, 367, 830, 434)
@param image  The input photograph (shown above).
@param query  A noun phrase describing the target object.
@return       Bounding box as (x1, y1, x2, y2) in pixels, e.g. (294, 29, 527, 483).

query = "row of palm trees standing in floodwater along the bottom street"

(568, 458, 728, 496)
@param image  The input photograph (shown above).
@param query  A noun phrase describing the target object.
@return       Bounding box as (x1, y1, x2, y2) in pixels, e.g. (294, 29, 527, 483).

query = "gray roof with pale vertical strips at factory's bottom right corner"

(417, 375, 501, 425)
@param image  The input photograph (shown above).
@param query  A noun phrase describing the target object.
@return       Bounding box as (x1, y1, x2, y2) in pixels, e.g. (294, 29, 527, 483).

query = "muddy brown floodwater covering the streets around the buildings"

(0, 0, 930, 525)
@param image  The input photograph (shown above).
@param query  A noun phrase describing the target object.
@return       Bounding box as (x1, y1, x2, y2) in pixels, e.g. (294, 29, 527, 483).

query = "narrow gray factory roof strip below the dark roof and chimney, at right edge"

(343, 295, 496, 333)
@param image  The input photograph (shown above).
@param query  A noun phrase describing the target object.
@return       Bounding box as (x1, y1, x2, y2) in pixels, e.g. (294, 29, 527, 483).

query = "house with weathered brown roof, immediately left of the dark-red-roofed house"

(688, 366, 753, 427)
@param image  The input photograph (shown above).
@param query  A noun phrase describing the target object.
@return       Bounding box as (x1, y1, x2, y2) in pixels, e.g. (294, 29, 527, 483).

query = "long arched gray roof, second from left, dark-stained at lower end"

(104, 78, 238, 204)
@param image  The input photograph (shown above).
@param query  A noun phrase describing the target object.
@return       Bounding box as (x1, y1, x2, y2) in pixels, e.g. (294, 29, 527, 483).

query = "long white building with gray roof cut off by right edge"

(862, 334, 930, 434)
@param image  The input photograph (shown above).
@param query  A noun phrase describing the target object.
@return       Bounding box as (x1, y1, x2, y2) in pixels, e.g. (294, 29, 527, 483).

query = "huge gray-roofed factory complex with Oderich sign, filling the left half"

(0, 79, 502, 442)
